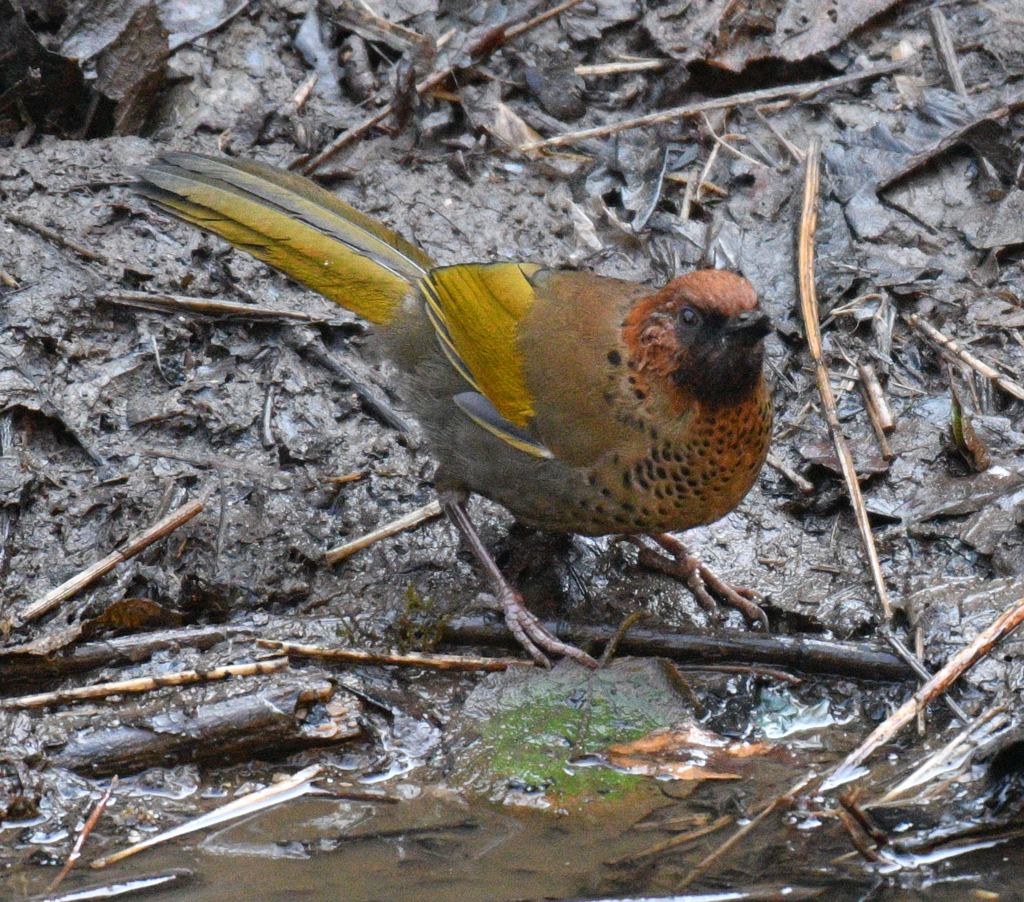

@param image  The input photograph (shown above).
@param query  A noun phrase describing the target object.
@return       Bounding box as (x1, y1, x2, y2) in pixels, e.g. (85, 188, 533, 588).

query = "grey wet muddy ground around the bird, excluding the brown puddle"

(0, 0, 1024, 898)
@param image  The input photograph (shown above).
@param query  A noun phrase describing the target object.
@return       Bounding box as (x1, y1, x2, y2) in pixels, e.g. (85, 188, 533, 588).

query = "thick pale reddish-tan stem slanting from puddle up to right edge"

(822, 598, 1024, 789)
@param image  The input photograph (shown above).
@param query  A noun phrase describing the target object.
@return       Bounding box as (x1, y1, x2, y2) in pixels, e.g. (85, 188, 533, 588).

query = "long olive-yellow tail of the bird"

(136, 154, 434, 325)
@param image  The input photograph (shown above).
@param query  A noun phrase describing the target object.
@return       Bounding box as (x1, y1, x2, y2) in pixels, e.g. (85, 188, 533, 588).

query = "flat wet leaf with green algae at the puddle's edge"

(449, 658, 692, 810)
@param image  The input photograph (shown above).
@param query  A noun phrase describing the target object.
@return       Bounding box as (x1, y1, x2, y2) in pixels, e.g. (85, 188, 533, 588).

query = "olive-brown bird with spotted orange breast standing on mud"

(135, 153, 773, 667)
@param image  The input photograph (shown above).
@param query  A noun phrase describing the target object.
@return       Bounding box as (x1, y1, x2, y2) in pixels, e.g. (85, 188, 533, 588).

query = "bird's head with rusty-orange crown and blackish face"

(623, 269, 772, 409)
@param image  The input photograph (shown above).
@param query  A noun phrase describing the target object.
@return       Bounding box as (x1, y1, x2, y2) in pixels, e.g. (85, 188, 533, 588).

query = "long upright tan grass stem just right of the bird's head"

(798, 136, 892, 620)
